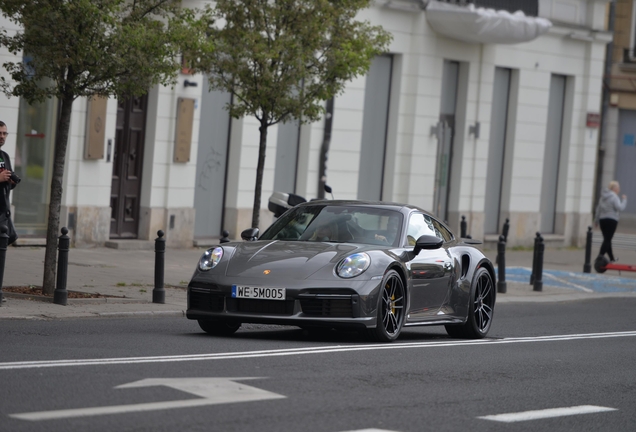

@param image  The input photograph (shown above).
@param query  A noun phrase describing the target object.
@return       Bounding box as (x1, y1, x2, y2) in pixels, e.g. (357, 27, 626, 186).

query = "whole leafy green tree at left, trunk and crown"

(0, 0, 209, 294)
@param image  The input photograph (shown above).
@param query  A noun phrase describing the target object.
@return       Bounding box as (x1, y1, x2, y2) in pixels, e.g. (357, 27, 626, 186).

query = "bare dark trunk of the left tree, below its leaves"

(42, 97, 74, 295)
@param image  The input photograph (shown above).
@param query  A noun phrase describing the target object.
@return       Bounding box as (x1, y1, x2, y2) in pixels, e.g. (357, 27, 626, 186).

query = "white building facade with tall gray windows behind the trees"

(0, 0, 612, 247)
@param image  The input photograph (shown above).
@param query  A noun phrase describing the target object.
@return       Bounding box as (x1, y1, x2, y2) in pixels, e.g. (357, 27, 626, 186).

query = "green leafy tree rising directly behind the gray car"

(191, 0, 391, 228)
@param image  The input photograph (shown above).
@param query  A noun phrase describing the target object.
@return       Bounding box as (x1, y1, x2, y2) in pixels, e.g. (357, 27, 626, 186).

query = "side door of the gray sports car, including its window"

(407, 212, 453, 321)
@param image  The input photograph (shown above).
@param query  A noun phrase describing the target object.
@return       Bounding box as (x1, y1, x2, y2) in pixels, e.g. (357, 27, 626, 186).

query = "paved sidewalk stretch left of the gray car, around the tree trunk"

(0, 247, 204, 319)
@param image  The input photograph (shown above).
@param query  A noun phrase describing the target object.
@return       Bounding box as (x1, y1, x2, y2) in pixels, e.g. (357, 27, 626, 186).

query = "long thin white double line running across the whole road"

(0, 331, 636, 370)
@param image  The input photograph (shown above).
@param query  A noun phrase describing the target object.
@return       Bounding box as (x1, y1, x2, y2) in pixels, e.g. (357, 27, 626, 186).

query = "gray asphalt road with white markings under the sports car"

(0, 298, 636, 432)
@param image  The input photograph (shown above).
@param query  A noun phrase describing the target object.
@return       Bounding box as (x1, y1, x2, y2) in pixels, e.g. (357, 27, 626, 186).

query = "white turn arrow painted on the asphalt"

(9, 378, 286, 421)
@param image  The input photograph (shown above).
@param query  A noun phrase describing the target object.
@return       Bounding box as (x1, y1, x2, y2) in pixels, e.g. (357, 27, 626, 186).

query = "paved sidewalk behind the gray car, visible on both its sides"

(0, 243, 636, 319)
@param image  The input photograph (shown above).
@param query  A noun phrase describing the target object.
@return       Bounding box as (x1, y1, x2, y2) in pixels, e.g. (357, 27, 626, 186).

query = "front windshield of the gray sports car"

(260, 205, 403, 246)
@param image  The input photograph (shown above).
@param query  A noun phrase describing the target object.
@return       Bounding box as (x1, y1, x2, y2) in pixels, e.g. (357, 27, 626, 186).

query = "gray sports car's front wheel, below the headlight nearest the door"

(367, 270, 406, 342)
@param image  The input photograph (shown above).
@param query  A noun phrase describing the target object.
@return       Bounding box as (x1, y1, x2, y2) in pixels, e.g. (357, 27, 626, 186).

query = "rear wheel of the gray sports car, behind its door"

(445, 267, 496, 339)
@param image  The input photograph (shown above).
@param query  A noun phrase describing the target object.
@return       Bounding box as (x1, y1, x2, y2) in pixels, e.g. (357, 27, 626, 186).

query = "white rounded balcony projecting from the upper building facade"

(426, 1, 552, 44)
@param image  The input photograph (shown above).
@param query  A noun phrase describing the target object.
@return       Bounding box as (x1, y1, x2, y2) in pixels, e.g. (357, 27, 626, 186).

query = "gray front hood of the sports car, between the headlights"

(226, 240, 368, 279)
